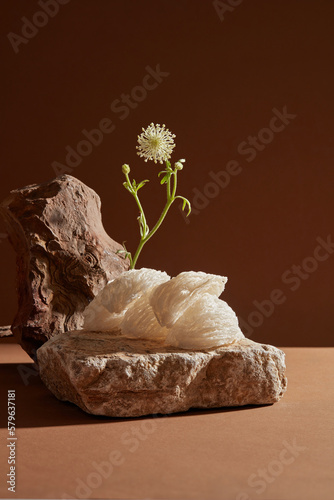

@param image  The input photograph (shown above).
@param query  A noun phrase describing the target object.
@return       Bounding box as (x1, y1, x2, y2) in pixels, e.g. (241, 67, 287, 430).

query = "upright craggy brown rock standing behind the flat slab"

(0, 175, 128, 357)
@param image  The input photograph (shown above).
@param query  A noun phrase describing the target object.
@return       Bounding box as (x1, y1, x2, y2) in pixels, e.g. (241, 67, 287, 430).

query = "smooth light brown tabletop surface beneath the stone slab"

(0, 343, 334, 500)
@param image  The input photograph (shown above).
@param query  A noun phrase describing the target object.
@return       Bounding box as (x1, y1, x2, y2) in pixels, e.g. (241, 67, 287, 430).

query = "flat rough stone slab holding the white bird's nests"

(37, 331, 287, 417)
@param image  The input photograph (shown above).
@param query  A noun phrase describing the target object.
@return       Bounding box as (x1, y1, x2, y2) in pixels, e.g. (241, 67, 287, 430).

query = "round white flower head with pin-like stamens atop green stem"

(137, 123, 175, 163)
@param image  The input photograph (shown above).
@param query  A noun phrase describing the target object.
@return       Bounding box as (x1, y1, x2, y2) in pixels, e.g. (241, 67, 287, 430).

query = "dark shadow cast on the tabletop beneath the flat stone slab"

(0, 363, 268, 429)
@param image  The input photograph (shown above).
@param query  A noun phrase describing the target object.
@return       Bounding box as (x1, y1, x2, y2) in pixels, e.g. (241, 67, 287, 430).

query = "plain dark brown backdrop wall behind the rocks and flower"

(0, 0, 334, 346)
